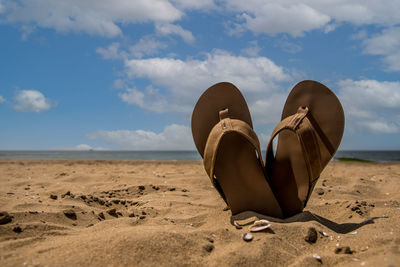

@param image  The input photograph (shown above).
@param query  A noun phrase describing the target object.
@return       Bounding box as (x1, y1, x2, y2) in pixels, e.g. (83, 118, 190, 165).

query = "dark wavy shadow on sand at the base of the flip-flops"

(231, 211, 388, 234)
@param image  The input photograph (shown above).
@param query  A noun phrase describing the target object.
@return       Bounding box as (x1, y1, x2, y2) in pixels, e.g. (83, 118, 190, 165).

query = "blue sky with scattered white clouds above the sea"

(0, 0, 400, 150)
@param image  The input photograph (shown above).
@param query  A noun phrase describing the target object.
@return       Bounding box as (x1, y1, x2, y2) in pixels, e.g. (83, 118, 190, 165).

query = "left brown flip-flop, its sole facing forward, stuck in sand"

(192, 82, 282, 217)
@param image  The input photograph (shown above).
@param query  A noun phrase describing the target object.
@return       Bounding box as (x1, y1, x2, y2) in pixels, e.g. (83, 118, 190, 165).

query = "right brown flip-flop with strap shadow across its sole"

(265, 80, 344, 217)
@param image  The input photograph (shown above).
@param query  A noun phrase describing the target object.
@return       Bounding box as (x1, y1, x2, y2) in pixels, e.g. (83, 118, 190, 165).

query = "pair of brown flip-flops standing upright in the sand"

(192, 80, 344, 218)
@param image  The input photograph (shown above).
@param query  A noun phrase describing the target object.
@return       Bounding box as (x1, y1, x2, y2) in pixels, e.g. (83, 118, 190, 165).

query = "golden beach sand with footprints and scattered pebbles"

(0, 159, 400, 266)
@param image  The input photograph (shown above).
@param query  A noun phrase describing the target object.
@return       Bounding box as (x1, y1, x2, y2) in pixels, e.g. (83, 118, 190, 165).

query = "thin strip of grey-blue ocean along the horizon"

(0, 150, 400, 162)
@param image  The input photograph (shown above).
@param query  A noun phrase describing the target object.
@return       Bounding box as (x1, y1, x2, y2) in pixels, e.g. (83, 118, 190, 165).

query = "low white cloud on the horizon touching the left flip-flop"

(88, 124, 194, 150)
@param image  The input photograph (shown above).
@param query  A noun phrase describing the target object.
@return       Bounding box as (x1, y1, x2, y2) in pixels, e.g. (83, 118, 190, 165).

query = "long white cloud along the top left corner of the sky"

(2, 0, 183, 37)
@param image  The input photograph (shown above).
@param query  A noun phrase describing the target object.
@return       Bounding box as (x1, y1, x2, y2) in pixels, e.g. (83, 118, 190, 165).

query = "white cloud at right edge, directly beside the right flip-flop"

(338, 80, 400, 133)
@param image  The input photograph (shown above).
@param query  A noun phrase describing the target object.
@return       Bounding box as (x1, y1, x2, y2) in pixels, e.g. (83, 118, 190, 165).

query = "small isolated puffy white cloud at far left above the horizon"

(14, 90, 51, 113)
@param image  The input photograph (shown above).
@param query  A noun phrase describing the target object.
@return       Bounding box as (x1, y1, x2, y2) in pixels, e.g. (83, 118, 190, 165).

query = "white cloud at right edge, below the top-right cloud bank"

(363, 27, 400, 71)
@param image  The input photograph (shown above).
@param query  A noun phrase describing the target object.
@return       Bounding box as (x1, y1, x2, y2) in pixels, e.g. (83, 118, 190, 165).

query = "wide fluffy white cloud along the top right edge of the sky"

(224, 0, 400, 36)
